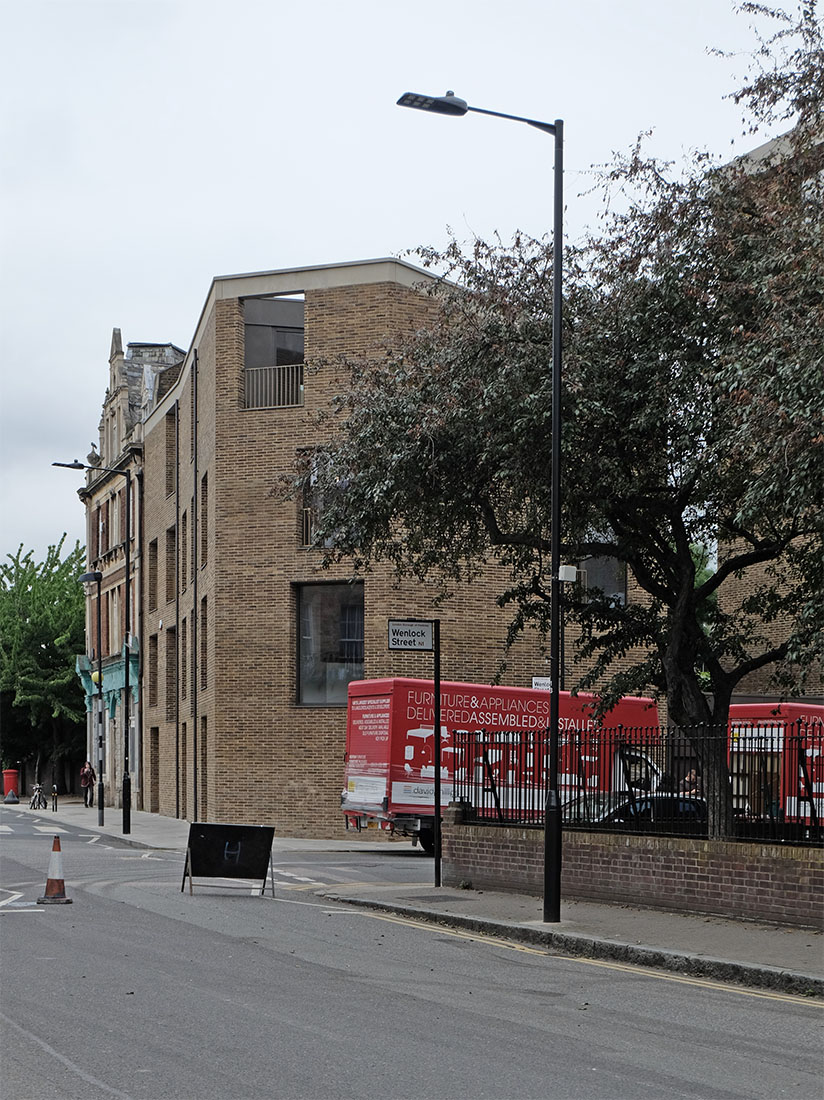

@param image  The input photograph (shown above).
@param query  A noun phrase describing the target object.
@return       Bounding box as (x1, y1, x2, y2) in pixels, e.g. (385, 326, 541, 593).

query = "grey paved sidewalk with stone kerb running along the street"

(8, 799, 824, 999)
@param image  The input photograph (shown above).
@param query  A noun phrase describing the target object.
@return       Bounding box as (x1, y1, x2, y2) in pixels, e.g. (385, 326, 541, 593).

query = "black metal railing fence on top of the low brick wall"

(453, 719, 824, 846)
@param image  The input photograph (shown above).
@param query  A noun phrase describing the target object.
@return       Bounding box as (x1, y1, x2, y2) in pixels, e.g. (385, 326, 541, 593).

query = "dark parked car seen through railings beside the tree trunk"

(564, 791, 707, 833)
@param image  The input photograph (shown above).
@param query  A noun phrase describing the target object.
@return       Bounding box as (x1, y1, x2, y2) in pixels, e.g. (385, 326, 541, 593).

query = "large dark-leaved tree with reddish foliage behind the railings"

(298, 2, 824, 834)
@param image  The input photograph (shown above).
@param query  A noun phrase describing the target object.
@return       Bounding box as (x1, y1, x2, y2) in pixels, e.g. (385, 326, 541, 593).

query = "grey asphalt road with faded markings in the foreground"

(0, 811, 822, 1100)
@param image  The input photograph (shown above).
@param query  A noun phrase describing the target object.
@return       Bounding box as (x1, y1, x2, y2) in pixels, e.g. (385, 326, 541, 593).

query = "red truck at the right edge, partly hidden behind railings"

(729, 702, 824, 825)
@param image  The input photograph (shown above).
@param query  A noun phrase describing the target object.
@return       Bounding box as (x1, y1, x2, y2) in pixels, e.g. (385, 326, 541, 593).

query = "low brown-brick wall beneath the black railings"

(441, 807, 824, 927)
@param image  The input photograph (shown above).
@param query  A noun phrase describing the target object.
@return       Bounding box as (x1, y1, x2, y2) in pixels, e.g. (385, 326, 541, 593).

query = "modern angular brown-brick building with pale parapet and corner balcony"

(134, 260, 556, 835)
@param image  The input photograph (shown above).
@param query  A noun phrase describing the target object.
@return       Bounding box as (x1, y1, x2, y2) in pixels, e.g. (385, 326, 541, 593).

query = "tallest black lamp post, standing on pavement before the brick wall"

(397, 91, 563, 923)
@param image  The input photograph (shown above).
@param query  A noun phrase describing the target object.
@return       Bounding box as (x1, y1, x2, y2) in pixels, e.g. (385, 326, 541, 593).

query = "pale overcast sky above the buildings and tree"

(0, 0, 787, 559)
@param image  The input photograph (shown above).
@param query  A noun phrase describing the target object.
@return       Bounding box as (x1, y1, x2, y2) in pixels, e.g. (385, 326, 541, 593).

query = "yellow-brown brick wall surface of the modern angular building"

(143, 284, 572, 836)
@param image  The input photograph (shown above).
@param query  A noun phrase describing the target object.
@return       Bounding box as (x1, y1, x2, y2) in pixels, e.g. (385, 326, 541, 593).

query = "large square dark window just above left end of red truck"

(297, 582, 363, 706)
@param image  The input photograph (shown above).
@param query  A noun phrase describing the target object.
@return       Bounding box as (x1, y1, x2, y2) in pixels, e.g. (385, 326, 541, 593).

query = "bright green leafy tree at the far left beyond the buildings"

(0, 536, 86, 772)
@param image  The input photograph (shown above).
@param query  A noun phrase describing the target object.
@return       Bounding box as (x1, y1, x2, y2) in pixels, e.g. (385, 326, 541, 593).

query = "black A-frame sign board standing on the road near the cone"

(180, 822, 275, 895)
